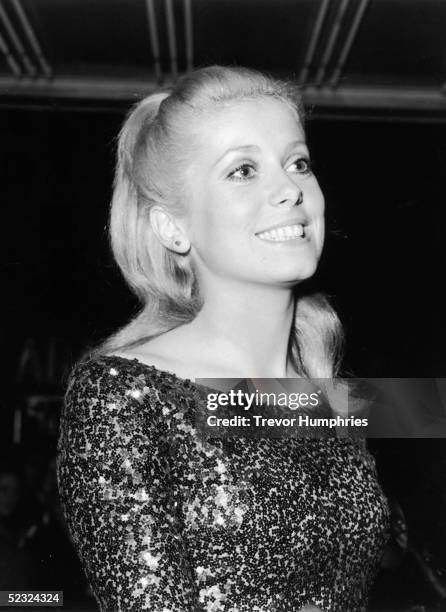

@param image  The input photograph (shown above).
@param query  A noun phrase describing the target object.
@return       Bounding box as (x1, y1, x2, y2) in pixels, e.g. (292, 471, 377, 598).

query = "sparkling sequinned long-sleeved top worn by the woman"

(58, 356, 389, 612)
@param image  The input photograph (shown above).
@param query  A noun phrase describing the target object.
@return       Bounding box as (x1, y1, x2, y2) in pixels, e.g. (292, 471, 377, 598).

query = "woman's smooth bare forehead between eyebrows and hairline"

(190, 98, 305, 155)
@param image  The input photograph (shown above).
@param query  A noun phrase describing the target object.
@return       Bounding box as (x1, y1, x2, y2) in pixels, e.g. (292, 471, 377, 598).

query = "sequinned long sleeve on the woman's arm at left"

(58, 362, 198, 612)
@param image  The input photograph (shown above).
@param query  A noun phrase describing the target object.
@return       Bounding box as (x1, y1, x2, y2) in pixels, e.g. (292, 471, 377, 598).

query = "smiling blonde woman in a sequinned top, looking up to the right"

(58, 66, 388, 612)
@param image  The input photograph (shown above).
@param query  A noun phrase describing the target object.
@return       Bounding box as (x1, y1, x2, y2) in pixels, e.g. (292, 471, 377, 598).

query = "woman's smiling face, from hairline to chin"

(180, 98, 324, 287)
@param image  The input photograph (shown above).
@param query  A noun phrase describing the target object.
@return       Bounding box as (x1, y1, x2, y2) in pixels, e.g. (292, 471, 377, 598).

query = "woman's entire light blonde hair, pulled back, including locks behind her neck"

(95, 66, 342, 378)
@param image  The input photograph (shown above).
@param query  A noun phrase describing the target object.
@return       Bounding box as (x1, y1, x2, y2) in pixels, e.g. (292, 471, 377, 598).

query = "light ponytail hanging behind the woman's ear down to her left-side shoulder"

(94, 92, 201, 354)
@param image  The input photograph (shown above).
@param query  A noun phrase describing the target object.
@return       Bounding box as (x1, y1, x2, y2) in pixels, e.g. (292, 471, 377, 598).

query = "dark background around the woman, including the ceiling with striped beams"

(0, 0, 446, 612)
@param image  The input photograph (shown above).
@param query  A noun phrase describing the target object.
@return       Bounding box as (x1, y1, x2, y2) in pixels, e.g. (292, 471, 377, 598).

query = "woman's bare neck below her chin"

(183, 283, 295, 378)
